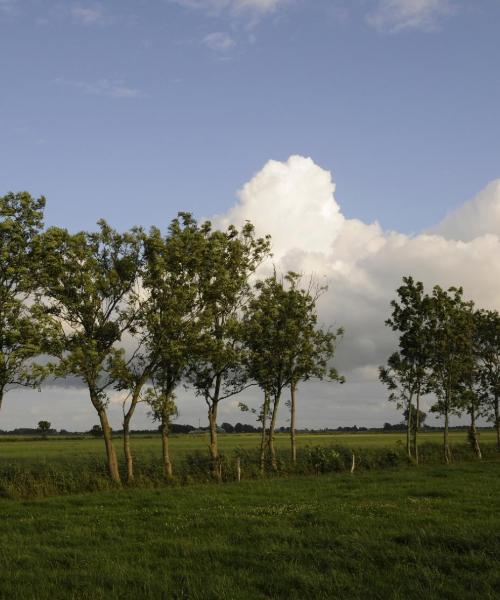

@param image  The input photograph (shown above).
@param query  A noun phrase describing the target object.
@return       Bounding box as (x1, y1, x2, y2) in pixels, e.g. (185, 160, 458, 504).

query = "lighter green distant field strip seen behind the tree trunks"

(0, 431, 495, 468)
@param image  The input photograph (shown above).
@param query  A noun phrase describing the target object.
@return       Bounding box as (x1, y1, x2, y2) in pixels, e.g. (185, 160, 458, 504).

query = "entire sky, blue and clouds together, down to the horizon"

(0, 0, 500, 429)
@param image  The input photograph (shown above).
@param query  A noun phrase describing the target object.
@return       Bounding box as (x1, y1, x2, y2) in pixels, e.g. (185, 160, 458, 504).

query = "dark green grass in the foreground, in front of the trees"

(0, 461, 500, 600)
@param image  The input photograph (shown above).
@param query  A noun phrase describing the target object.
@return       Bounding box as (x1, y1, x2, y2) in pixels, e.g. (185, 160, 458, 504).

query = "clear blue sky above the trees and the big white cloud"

(0, 0, 500, 232)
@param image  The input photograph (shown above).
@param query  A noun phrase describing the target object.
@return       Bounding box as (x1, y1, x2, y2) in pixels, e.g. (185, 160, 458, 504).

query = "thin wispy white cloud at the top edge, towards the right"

(366, 0, 453, 32)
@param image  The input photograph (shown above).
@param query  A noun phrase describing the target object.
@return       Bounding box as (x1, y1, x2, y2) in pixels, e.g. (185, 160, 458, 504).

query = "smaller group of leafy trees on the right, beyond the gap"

(380, 277, 500, 463)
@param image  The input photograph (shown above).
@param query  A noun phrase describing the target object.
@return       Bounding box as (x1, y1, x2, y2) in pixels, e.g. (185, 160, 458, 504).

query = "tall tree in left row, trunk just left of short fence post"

(188, 223, 269, 480)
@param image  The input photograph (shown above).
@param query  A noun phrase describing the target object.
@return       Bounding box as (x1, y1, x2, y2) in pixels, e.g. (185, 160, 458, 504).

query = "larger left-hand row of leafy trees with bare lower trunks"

(0, 193, 342, 482)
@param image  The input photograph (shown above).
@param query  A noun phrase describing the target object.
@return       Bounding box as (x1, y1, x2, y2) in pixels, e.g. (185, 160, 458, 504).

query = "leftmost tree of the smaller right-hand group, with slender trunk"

(380, 276, 430, 464)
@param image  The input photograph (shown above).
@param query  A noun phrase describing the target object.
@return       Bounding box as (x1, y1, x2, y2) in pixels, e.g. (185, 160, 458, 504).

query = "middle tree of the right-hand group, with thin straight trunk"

(428, 286, 473, 463)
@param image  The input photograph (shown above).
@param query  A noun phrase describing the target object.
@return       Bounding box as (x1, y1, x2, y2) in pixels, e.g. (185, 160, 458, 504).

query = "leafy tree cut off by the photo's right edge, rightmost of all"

(474, 310, 500, 451)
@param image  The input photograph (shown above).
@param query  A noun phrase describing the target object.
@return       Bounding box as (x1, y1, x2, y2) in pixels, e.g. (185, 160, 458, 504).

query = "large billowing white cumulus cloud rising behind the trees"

(218, 156, 500, 402)
